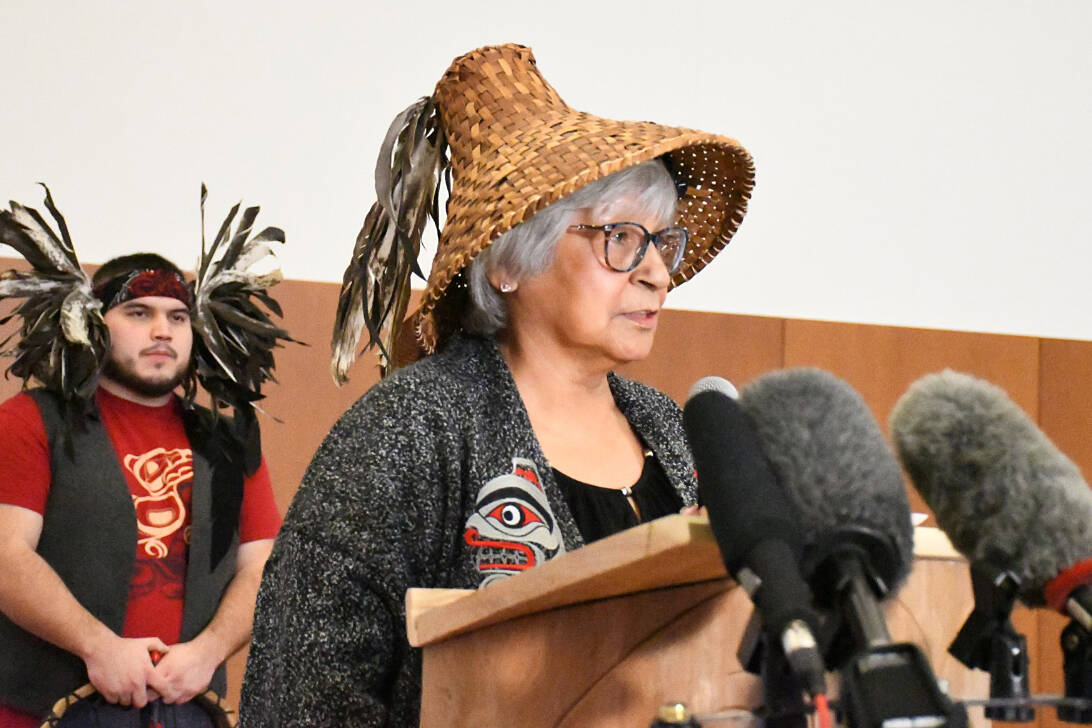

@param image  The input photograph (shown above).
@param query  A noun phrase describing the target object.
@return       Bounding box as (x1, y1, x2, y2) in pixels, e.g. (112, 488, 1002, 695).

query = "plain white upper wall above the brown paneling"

(0, 0, 1092, 339)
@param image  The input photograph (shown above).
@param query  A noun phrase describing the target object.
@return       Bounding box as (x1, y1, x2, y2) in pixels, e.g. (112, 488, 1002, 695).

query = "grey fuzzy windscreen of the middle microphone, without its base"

(740, 368, 913, 646)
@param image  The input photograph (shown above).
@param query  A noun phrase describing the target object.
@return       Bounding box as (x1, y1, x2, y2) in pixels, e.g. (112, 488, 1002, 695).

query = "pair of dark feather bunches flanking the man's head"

(0, 184, 295, 470)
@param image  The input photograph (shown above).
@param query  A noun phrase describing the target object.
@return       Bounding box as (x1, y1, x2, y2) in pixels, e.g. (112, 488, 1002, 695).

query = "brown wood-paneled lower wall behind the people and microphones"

(0, 259, 1092, 727)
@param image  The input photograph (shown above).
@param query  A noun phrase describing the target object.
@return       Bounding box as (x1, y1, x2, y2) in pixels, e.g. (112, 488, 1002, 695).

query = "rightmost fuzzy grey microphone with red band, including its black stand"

(891, 370, 1092, 723)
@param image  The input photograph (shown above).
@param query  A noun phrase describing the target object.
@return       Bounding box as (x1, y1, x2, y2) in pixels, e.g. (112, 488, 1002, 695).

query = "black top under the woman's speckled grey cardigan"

(551, 451, 683, 544)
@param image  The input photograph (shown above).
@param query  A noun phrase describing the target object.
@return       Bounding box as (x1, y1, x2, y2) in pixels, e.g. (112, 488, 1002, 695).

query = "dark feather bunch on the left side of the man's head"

(0, 184, 110, 421)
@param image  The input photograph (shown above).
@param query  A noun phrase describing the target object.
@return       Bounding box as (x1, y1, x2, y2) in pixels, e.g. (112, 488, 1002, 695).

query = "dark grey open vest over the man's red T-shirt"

(0, 390, 244, 714)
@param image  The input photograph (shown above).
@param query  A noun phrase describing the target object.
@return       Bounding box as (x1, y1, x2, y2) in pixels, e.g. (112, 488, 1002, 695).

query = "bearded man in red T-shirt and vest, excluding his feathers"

(0, 191, 280, 726)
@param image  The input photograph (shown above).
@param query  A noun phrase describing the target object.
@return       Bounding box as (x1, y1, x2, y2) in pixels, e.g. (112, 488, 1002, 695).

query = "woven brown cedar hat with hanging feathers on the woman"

(334, 45, 755, 381)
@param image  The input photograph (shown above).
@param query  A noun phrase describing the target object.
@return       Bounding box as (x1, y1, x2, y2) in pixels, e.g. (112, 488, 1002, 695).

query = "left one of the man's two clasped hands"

(83, 631, 167, 707)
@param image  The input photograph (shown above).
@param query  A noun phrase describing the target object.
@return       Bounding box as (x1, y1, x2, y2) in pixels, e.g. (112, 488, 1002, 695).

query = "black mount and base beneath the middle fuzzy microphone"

(810, 528, 968, 728)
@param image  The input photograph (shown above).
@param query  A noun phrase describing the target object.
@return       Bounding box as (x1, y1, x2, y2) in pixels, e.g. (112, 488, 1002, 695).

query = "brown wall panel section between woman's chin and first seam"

(618, 310, 784, 404)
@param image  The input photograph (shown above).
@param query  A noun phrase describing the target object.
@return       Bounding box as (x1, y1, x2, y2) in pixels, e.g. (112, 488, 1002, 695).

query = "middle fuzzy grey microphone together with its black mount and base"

(740, 368, 966, 728)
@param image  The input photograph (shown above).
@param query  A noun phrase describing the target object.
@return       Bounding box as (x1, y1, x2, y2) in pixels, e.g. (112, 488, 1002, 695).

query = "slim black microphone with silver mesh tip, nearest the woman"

(683, 377, 826, 696)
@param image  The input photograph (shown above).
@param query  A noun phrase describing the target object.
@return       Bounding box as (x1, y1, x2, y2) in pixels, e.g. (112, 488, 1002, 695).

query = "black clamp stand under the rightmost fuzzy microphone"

(948, 563, 1030, 723)
